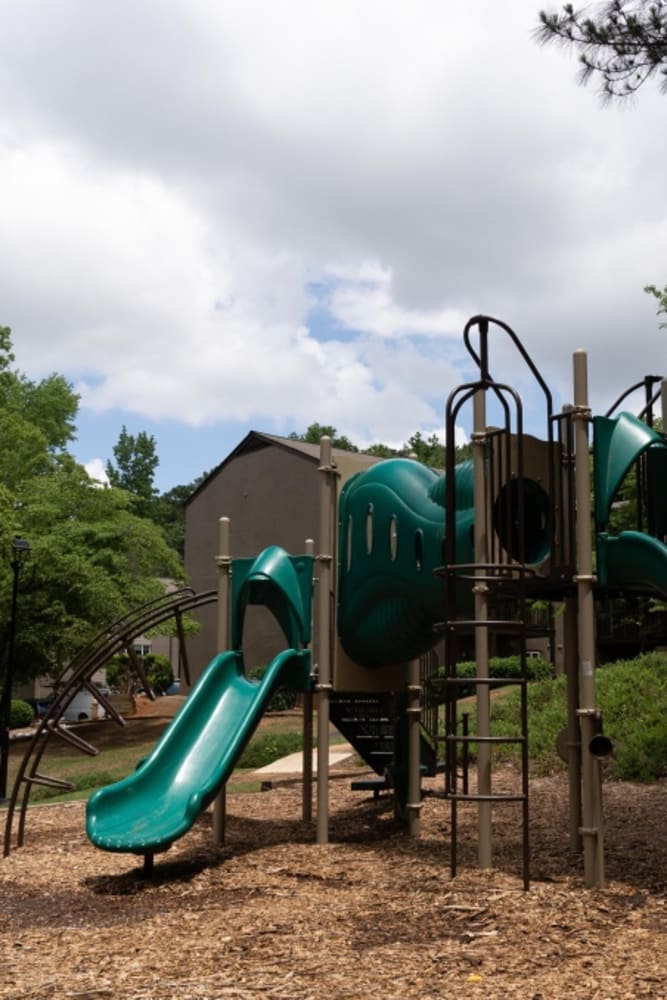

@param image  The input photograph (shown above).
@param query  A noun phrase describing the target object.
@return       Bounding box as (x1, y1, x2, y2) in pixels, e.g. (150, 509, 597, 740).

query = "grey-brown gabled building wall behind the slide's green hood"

(185, 445, 319, 679)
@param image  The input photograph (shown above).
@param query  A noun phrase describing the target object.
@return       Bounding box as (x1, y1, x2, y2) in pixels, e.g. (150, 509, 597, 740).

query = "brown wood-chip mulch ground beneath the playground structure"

(0, 760, 667, 1000)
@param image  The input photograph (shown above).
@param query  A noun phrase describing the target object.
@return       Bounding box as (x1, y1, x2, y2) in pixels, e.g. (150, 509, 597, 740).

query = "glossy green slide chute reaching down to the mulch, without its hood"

(86, 649, 310, 854)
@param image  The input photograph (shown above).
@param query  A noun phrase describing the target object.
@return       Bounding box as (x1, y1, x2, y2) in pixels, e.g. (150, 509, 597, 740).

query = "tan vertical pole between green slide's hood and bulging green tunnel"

(317, 437, 336, 844)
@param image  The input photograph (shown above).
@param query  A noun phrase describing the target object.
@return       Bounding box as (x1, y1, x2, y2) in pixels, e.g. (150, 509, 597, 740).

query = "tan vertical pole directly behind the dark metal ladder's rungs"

(472, 389, 491, 868)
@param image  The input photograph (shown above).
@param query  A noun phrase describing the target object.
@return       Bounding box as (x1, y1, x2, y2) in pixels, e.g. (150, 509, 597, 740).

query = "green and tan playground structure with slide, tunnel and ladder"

(5, 317, 667, 887)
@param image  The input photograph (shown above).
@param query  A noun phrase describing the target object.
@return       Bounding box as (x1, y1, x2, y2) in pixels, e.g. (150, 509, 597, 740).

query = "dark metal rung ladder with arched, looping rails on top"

(436, 316, 561, 889)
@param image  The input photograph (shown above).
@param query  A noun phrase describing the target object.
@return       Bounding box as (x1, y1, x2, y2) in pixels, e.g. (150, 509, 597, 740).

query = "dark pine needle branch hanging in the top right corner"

(536, 0, 667, 100)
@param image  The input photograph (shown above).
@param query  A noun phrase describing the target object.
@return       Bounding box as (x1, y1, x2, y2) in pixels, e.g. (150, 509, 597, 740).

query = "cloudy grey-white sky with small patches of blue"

(0, 0, 667, 489)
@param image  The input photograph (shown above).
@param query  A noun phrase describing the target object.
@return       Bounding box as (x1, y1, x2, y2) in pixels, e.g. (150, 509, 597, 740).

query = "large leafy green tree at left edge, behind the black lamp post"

(0, 327, 183, 680)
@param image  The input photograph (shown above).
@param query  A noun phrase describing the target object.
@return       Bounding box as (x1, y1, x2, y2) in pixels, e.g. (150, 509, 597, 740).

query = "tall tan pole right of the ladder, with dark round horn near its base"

(573, 351, 604, 888)
